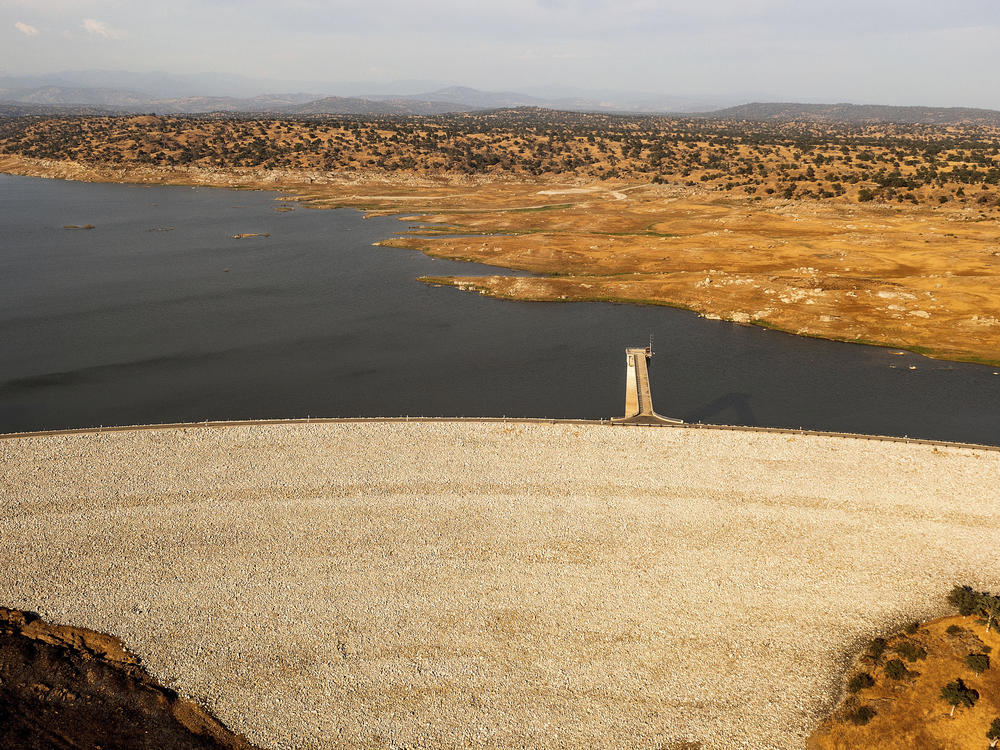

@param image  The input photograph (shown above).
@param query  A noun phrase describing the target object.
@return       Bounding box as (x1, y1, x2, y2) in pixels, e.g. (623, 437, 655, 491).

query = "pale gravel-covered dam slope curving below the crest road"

(0, 422, 1000, 749)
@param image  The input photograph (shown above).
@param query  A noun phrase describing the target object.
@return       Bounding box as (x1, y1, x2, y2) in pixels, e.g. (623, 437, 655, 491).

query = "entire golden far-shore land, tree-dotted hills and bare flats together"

(0, 111, 1000, 364)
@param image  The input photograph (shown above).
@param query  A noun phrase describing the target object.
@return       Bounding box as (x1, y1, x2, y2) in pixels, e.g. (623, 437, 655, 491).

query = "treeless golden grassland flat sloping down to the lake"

(362, 186, 1000, 362)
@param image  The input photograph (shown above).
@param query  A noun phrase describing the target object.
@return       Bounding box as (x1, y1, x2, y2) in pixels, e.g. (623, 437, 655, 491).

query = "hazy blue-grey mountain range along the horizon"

(0, 73, 1000, 126)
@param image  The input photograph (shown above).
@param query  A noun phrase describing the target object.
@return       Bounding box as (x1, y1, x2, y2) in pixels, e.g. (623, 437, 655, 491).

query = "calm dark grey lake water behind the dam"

(0, 175, 1000, 444)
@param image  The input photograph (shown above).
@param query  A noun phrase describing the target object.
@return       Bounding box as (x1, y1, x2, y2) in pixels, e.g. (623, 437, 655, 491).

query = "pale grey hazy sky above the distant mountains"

(0, 0, 1000, 109)
